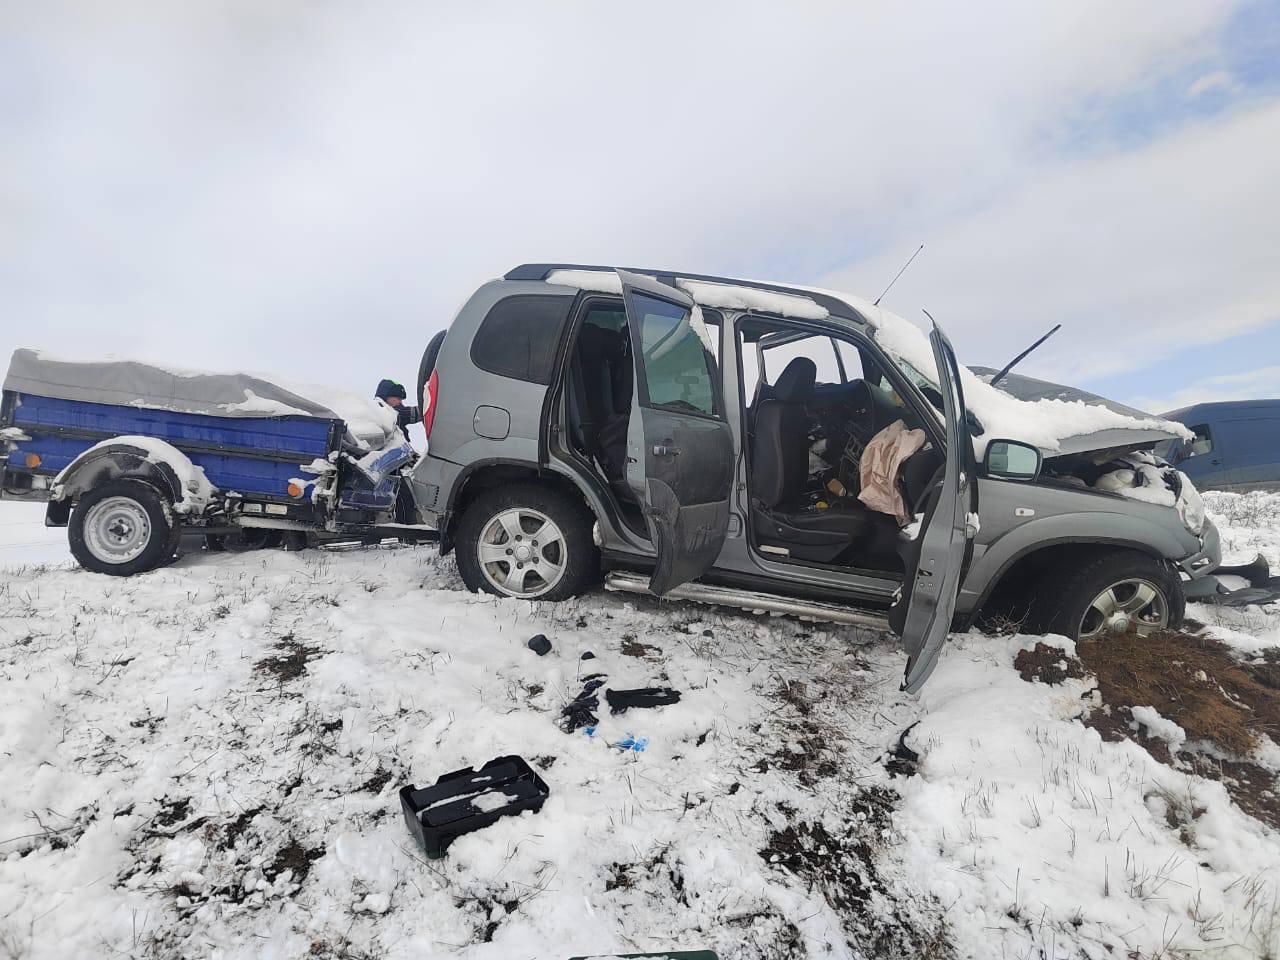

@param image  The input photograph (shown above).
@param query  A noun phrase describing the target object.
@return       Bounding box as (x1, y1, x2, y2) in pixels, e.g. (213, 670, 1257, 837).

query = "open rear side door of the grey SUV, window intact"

(618, 270, 733, 595)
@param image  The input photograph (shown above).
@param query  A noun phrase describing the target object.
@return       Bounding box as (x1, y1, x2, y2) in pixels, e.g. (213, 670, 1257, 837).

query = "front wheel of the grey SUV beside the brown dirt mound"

(1028, 550, 1187, 641)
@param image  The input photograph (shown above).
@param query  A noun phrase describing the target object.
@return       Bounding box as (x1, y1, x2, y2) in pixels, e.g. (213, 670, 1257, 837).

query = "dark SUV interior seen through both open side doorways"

(564, 298, 942, 575)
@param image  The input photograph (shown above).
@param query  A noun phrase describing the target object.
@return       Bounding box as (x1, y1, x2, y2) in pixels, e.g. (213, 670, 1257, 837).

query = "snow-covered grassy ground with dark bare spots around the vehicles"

(0, 494, 1280, 960)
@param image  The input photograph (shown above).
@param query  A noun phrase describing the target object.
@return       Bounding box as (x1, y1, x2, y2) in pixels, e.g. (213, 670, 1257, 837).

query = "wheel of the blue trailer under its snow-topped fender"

(67, 480, 182, 577)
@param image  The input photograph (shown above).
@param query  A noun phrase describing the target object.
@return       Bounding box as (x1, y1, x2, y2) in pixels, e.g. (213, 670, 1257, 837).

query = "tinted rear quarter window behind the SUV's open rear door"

(471, 294, 573, 384)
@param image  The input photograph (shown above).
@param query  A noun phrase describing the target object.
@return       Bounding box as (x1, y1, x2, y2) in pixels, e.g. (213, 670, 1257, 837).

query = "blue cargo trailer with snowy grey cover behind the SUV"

(0, 349, 434, 576)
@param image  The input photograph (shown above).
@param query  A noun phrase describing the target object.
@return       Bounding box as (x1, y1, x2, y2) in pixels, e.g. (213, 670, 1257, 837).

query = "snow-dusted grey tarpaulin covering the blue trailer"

(4, 349, 397, 449)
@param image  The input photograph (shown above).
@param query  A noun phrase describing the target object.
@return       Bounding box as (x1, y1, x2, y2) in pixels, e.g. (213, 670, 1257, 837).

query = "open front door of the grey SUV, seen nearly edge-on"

(888, 324, 978, 694)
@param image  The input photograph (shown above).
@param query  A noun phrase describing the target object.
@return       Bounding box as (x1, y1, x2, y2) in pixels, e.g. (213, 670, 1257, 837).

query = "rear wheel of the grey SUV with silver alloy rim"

(456, 484, 598, 600)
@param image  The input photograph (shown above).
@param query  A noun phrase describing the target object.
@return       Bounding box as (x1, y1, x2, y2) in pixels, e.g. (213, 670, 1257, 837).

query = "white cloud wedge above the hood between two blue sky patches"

(824, 101, 1280, 383)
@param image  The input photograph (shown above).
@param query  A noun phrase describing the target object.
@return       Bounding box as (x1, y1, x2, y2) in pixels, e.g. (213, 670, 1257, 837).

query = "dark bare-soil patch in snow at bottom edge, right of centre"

(760, 788, 952, 957)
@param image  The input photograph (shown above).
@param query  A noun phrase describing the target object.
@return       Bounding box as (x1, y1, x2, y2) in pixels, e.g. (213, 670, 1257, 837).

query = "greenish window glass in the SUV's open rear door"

(632, 293, 717, 416)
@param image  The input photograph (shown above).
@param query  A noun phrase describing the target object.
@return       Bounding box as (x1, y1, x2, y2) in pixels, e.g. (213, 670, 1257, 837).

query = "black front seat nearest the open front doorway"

(751, 357, 897, 563)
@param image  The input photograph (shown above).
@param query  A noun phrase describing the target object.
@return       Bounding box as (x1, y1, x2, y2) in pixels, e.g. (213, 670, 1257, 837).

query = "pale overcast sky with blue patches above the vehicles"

(0, 0, 1280, 410)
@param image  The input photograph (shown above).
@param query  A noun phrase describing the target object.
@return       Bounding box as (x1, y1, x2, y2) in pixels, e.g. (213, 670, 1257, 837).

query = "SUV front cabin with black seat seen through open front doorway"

(739, 319, 943, 573)
